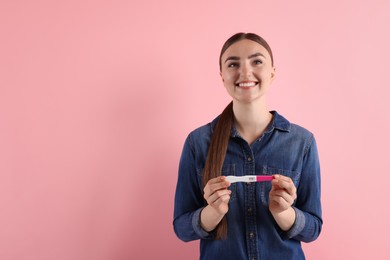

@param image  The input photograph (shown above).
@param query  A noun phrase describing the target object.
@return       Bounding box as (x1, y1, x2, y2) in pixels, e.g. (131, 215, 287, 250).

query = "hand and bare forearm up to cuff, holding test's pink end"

(269, 175, 297, 231)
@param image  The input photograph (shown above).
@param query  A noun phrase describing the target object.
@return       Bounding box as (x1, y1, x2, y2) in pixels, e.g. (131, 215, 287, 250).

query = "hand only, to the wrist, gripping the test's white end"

(203, 176, 232, 216)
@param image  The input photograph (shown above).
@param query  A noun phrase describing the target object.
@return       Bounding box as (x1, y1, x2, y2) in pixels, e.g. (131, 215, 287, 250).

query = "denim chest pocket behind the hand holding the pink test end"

(259, 166, 301, 207)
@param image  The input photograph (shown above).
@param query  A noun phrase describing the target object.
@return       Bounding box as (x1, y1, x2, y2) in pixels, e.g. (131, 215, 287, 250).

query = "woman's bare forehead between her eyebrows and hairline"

(222, 39, 271, 59)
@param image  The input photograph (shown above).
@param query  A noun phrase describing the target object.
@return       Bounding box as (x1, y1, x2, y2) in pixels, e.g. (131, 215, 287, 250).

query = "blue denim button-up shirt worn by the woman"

(173, 111, 322, 260)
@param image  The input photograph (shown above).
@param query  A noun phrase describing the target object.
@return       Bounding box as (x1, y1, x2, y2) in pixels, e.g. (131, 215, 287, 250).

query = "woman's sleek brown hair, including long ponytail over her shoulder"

(202, 33, 273, 239)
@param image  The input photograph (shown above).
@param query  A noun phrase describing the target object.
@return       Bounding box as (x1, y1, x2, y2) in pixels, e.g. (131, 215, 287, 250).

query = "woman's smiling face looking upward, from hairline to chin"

(221, 39, 275, 103)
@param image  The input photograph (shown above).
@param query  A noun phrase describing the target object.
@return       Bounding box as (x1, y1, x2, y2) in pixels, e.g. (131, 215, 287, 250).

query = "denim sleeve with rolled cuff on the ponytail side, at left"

(173, 136, 213, 242)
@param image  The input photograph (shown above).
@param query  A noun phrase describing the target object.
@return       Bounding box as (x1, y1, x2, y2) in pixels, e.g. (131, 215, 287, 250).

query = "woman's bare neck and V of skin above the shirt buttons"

(233, 99, 272, 144)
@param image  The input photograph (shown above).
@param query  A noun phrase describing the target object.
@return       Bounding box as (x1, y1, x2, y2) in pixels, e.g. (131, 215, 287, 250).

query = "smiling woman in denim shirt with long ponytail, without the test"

(173, 33, 322, 260)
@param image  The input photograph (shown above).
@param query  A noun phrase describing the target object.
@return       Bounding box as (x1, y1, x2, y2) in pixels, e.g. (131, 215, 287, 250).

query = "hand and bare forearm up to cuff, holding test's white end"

(200, 176, 232, 232)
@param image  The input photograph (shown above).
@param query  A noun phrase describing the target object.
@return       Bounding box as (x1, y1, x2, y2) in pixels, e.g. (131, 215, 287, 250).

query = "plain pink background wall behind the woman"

(0, 0, 390, 260)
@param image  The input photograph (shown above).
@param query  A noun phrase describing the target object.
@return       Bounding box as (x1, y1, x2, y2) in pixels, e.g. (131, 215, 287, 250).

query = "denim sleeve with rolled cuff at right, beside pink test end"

(284, 136, 323, 242)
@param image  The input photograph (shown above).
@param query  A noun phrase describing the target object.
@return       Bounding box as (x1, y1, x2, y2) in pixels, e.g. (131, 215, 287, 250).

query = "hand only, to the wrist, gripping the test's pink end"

(269, 174, 297, 214)
